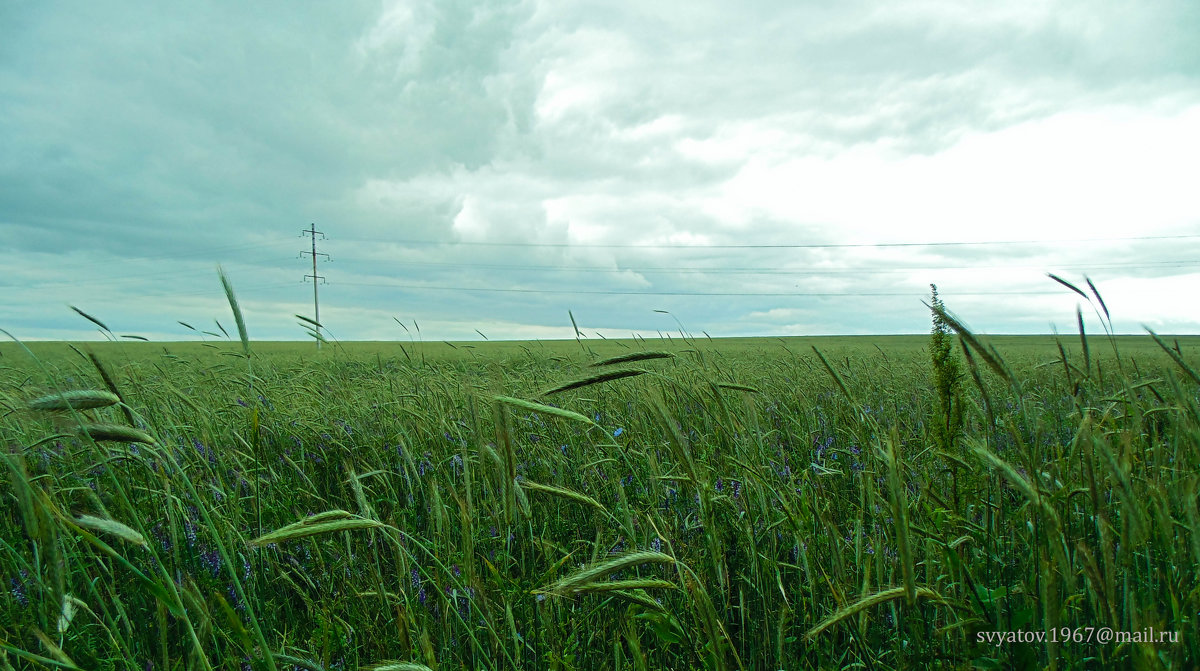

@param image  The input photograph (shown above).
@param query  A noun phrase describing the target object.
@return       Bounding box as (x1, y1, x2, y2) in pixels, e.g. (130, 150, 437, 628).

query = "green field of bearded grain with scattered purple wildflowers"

(0, 314, 1200, 671)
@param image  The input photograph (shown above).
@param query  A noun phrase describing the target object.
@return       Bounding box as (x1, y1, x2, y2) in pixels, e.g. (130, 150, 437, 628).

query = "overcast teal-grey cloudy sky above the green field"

(0, 0, 1200, 341)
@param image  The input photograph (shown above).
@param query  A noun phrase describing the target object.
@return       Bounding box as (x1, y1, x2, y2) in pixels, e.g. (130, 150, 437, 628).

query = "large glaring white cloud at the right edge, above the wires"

(710, 107, 1200, 242)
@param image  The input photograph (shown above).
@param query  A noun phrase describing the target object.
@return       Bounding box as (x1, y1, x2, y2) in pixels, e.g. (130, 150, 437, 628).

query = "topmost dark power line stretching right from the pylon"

(336, 235, 1200, 250)
